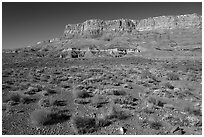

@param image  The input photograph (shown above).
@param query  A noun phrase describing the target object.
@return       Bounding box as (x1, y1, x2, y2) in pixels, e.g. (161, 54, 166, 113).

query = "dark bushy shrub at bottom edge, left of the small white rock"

(72, 116, 97, 134)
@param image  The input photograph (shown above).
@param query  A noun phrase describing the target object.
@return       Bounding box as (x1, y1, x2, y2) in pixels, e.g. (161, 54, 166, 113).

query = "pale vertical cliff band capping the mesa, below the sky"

(64, 14, 202, 38)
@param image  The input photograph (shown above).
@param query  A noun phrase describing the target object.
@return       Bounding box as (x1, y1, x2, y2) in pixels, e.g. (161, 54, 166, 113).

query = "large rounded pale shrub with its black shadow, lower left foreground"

(30, 109, 71, 126)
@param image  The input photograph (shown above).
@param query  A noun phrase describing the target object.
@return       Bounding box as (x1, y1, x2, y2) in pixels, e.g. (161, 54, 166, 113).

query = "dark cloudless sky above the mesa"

(2, 2, 202, 49)
